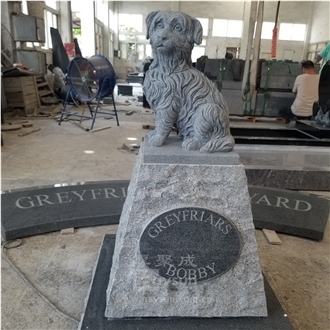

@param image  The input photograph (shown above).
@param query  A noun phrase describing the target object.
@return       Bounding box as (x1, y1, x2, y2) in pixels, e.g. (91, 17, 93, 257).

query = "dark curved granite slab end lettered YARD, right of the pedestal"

(249, 186, 330, 240)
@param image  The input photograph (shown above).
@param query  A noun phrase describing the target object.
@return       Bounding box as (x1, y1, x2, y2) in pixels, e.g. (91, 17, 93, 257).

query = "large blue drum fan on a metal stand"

(59, 55, 119, 129)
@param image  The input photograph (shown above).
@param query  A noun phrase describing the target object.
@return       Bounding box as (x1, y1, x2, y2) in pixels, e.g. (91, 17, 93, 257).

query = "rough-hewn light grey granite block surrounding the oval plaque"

(105, 137, 267, 318)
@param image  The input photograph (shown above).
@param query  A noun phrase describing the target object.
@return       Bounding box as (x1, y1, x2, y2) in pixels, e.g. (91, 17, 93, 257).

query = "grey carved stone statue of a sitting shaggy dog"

(143, 11, 235, 153)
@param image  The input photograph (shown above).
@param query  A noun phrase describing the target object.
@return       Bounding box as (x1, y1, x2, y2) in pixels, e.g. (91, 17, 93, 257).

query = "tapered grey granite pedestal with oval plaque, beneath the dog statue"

(105, 137, 267, 318)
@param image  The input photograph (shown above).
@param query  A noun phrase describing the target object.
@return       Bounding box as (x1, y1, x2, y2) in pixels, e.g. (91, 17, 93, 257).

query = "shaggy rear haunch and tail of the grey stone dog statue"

(194, 103, 235, 153)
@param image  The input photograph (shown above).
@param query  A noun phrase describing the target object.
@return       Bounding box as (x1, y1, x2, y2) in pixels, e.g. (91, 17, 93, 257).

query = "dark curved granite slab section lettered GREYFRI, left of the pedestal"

(1, 180, 128, 240)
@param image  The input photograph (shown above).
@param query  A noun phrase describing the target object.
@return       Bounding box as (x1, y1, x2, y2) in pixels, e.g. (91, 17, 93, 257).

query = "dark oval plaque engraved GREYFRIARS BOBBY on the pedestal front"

(140, 207, 242, 283)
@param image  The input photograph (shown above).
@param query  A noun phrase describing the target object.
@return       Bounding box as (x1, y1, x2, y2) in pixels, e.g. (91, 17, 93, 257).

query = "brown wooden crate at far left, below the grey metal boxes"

(3, 76, 40, 115)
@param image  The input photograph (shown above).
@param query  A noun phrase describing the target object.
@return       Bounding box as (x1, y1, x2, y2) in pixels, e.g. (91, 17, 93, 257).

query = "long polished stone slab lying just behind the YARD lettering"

(234, 145, 330, 191)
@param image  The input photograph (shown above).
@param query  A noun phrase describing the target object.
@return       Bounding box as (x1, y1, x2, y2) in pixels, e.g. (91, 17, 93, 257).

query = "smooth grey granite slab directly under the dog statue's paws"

(143, 136, 239, 165)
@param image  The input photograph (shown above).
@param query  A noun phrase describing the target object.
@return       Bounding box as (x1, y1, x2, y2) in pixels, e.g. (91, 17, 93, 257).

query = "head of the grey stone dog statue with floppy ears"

(146, 11, 203, 67)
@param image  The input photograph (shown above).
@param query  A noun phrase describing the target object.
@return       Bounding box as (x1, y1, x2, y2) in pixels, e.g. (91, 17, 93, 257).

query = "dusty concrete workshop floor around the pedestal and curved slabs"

(1, 97, 330, 330)
